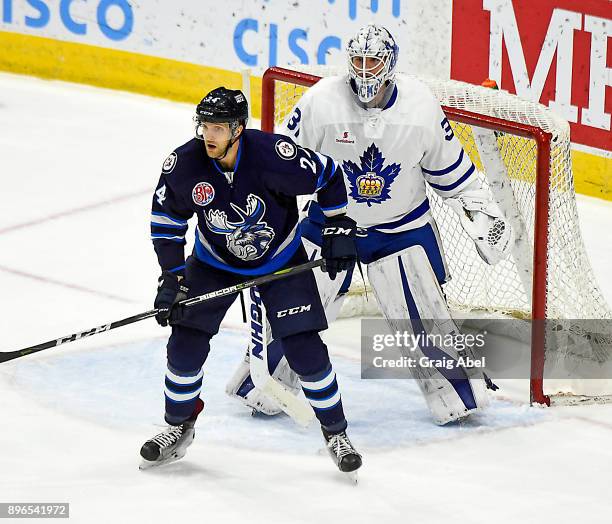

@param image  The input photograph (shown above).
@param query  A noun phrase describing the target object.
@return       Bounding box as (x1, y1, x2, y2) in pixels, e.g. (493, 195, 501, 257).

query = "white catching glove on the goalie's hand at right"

(446, 180, 514, 265)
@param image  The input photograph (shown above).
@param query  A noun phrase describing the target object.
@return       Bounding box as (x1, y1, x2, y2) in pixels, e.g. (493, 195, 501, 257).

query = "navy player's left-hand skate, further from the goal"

(139, 401, 204, 470)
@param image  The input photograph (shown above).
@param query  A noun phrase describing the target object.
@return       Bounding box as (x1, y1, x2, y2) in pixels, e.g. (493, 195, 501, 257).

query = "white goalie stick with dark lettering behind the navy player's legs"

(249, 287, 314, 427)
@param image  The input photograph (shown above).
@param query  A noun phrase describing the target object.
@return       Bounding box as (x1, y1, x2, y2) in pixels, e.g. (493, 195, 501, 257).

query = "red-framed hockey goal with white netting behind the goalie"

(261, 67, 612, 405)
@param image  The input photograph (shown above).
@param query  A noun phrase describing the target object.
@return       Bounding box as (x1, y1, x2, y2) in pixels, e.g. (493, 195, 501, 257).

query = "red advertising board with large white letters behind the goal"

(451, 0, 612, 150)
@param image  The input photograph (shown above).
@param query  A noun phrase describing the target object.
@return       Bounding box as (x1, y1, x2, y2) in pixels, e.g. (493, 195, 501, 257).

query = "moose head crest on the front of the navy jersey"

(204, 193, 274, 261)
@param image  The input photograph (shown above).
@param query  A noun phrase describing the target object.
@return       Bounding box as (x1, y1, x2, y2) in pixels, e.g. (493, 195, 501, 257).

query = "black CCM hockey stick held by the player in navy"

(0, 259, 323, 363)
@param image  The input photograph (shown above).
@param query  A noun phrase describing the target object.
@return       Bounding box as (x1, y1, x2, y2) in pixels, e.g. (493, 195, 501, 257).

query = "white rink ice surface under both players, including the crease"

(0, 74, 612, 524)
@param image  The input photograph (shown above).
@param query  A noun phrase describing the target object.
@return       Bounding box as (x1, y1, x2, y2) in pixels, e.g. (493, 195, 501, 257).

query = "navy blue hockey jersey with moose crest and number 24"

(151, 129, 347, 275)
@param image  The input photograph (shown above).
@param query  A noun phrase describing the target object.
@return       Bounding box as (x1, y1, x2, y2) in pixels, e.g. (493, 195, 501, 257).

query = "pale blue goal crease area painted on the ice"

(12, 330, 548, 453)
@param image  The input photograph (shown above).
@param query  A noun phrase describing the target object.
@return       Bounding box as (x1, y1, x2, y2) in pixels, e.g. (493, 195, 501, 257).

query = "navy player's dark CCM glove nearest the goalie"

(321, 215, 357, 280)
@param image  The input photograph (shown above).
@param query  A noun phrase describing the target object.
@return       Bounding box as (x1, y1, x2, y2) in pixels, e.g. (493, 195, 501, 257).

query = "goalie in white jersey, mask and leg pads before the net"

(228, 25, 513, 424)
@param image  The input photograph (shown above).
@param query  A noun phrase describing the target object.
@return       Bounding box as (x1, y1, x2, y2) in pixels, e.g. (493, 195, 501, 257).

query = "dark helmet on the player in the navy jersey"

(194, 87, 249, 138)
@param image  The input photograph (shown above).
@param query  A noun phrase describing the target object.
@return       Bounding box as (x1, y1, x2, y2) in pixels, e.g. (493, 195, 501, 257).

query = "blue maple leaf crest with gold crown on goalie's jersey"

(342, 143, 402, 206)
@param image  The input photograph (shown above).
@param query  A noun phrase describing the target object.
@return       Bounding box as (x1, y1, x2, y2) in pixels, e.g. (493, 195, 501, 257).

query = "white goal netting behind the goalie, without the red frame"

(273, 68, 612, 326)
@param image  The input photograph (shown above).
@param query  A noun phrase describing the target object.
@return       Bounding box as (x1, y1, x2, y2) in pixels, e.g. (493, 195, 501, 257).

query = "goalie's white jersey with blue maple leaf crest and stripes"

(280, 74, 477, 233)
